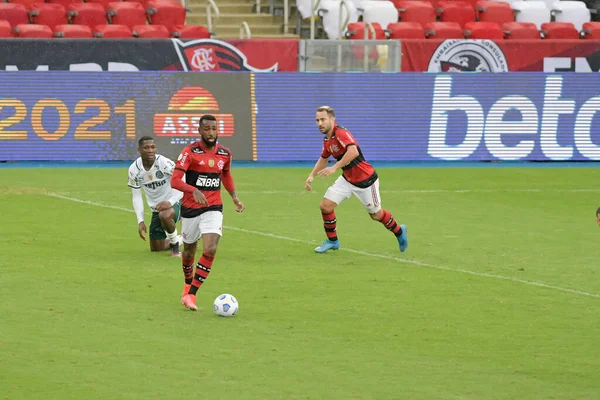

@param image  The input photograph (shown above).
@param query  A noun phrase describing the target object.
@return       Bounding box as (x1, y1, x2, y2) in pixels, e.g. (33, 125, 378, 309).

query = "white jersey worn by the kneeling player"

(127, 154, 183, 211)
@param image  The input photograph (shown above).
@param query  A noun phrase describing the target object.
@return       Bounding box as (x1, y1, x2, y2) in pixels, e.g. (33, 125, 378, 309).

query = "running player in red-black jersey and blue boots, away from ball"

(305, 106, 408, 253)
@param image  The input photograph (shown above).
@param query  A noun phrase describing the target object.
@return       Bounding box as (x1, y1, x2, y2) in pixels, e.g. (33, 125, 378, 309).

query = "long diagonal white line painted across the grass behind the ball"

(44, 193, 600, 298)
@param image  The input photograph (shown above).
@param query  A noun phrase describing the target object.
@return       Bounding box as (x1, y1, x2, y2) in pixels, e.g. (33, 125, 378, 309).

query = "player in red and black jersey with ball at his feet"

(171, 115, 244, 311)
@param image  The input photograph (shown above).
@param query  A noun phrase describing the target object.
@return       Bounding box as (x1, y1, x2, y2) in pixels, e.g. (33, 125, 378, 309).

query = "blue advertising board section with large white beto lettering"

(255, 72, 600, 161)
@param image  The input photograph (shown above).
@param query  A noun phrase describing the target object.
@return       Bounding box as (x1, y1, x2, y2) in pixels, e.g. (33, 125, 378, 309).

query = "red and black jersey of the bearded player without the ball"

(321, 125, 377, 188)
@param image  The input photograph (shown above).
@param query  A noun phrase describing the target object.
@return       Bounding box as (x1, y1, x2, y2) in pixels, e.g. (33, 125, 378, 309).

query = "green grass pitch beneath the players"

(0, 165, 600, 400)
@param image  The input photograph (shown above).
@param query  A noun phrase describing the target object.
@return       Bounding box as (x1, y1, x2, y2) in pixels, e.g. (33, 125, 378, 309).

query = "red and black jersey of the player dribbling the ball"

(175, 141, 231, 218)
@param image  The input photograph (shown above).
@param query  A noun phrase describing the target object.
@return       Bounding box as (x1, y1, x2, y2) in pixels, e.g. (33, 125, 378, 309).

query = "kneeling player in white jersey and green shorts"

(128, 136, 183, 257)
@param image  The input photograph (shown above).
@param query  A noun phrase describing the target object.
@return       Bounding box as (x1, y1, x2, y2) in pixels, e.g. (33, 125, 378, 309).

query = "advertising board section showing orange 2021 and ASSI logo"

(0, 71, 253, 161)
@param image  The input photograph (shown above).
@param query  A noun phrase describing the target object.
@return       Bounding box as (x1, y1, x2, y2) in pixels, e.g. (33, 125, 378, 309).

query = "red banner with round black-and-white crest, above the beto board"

(402, 39, 600, 72)
